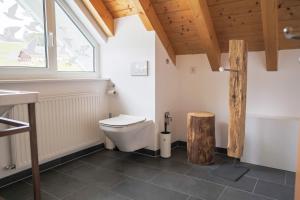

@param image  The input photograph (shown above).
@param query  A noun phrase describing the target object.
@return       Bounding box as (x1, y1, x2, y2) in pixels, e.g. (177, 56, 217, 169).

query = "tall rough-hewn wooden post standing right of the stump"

(227, 40, 247, 158)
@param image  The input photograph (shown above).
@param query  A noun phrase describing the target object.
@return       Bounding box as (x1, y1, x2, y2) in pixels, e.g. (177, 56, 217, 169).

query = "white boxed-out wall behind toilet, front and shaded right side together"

(101, 16, 182, 150)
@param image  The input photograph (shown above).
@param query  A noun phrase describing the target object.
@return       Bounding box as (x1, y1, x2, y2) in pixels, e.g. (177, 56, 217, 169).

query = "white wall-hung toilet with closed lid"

(99, 115, 154, 152)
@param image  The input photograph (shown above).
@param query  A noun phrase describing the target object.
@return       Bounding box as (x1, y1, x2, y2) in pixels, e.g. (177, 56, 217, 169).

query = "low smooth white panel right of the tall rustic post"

(242, 115, 300, 171)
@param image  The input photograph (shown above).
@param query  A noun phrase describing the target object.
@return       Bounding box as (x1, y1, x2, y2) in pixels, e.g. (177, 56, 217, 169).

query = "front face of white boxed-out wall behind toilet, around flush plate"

(101, 16, 155, 149)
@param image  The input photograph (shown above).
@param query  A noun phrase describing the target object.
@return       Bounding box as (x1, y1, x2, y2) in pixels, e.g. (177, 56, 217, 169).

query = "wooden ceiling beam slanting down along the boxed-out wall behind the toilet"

(131, 0, 176, 65)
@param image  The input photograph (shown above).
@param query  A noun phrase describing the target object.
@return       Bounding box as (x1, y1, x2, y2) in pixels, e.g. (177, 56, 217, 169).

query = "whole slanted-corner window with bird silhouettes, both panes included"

(0, 0, 99, 74)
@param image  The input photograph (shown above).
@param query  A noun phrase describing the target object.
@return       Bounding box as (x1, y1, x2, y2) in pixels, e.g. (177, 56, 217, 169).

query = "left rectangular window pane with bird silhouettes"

(0, 0, 46, 67)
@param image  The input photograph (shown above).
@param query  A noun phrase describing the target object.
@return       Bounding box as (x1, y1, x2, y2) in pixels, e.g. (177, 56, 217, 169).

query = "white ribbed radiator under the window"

(10, 94, 103, 169)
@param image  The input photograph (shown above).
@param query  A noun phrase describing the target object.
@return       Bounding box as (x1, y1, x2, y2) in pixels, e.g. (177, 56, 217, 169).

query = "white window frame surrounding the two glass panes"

(0, 0, 100, 80)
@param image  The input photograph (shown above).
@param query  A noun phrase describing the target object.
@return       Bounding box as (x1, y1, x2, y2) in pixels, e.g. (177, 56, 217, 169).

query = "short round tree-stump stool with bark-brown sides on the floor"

(187, 112, 216, 164)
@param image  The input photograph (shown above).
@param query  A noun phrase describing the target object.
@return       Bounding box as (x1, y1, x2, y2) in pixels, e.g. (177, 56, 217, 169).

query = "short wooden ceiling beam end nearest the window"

(83, 0, 115, 37)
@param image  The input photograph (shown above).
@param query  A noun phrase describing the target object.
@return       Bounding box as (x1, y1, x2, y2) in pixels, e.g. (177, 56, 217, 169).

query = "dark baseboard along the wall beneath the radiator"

(0, 144, 104, 188)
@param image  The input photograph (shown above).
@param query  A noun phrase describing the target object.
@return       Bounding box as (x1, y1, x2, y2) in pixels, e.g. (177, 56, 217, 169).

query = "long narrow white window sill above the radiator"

(0, 78, 110, 84)
